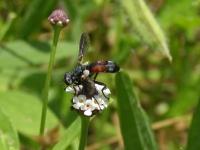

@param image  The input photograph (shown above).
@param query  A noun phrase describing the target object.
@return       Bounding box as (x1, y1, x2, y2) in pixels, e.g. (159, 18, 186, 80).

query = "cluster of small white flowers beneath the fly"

(66, 84, 110, 116)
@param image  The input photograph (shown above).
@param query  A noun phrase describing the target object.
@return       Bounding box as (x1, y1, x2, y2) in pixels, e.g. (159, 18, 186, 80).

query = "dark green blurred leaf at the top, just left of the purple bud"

(19, 0, 58, 38)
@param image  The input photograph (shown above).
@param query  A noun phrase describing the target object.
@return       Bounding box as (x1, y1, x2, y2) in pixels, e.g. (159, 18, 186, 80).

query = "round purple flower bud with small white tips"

(48, 9, 70, 27)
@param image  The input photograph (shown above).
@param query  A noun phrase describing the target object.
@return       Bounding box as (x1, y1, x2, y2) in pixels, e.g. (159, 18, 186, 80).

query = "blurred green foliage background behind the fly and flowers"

(0, 0, 200, 150)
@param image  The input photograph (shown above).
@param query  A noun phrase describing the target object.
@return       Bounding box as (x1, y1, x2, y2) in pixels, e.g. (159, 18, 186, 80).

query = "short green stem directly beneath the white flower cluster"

(78, 116, 90, 150)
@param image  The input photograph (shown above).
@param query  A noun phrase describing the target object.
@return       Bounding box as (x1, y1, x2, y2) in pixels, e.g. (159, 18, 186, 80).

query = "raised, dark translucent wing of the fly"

(78, 33, 90, 64)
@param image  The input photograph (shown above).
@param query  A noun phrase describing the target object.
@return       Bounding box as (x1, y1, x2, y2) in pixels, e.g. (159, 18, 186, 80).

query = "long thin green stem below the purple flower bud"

(40, 26, 61, 135)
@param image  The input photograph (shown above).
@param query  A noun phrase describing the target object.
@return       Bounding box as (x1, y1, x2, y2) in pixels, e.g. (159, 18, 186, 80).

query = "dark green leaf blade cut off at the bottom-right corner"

(187, 100, 200, 150)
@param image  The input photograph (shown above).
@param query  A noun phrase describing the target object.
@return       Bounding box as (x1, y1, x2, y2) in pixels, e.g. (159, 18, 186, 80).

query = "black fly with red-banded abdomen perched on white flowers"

(64, 33, 119, 115)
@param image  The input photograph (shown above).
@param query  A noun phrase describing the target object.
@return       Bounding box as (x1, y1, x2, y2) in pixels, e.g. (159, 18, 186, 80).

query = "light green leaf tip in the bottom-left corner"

(0, 109, 19, 150)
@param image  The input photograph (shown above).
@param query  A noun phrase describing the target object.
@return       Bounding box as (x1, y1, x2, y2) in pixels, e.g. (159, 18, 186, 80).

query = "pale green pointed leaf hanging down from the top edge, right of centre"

(121, 0, 172, 61)
